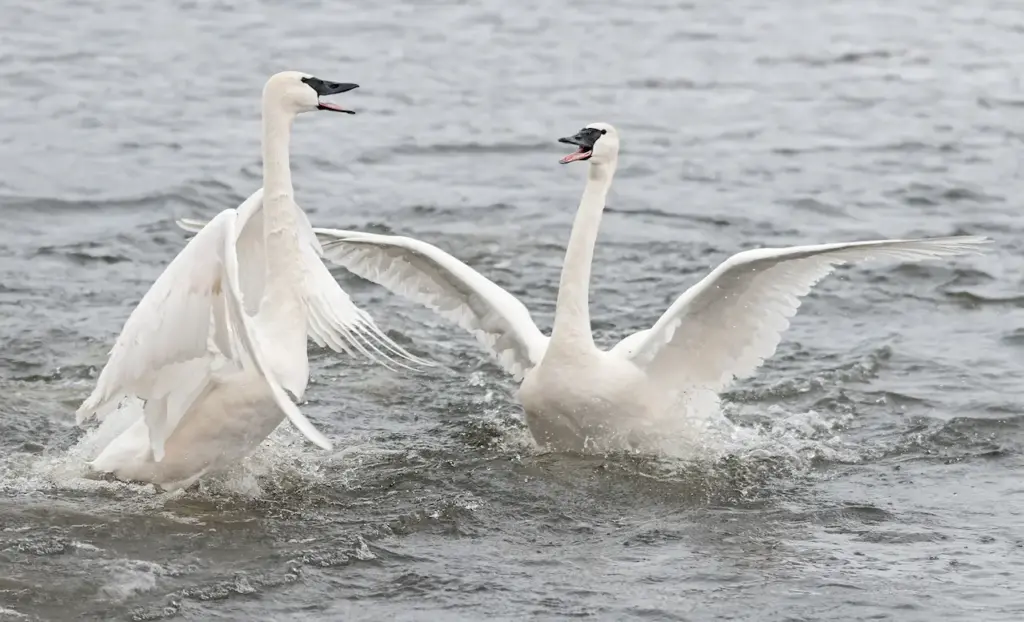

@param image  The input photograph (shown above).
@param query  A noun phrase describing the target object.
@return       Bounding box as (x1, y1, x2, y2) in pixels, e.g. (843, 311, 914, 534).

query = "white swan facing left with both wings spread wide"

(180, 123, 987, 452)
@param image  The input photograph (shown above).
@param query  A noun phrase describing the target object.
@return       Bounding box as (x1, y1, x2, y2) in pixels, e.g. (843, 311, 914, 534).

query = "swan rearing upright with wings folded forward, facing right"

(76, 71, 420, 490)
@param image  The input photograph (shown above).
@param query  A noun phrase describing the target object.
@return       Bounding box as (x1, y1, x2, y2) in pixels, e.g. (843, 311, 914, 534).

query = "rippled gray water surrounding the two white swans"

(0, 0, 1024, 621)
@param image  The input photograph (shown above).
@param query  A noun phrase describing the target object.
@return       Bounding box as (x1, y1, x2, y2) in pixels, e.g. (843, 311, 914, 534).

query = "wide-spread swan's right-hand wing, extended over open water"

(612, 236, 987, 391)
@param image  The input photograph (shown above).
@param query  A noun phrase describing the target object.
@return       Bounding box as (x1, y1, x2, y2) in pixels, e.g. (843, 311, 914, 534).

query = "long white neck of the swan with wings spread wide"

(551, 160, 615, 349)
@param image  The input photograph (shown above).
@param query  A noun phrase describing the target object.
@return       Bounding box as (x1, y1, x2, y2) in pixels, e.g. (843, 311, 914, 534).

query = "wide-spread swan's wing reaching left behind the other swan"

(313, 229, 548, 380)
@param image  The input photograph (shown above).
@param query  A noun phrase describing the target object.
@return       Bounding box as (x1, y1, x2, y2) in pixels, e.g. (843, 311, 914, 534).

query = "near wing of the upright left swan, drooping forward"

(76, 209, 331, 461)
